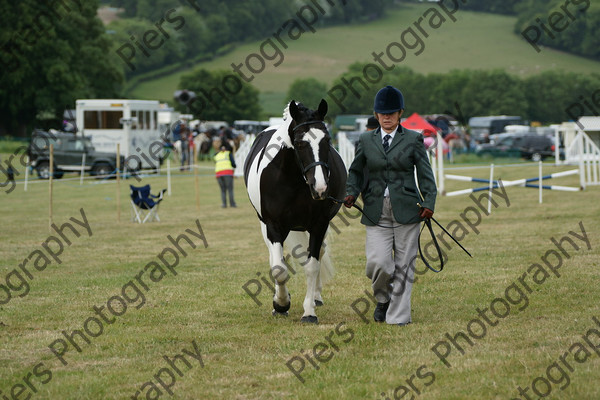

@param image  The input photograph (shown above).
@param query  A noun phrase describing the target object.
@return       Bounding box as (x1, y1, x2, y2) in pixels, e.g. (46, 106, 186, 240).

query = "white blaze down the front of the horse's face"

(295, 128, 329, 200)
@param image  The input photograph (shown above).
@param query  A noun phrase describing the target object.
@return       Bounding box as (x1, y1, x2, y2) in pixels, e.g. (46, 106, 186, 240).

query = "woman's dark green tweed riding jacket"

(346, 127, 437, 226)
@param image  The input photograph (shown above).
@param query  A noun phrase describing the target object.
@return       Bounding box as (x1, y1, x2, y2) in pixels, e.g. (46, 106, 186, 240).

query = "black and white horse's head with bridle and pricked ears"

(289, 100, 331, 200)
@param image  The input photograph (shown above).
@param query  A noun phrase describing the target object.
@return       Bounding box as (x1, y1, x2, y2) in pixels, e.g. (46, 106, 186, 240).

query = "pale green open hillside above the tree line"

(129, 4, 600, 114)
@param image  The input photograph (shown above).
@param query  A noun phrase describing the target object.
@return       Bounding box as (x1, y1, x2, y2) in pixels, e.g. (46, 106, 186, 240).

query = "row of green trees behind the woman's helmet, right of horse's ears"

(326, 63, 600, 123)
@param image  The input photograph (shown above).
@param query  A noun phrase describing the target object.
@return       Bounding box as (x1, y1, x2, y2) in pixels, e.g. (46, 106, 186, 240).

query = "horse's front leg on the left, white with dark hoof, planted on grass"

(260, 222, 291, 315)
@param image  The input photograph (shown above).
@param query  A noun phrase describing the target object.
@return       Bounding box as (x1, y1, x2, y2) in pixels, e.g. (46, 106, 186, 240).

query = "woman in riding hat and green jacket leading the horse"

(344, 86, 437, 326)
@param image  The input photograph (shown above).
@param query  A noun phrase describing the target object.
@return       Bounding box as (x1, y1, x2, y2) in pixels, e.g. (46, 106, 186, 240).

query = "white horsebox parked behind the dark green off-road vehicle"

(76, 99, 163, 169)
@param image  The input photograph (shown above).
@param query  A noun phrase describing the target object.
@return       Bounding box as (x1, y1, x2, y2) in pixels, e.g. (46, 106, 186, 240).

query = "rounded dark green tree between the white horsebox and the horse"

(177, 69, 261, 123)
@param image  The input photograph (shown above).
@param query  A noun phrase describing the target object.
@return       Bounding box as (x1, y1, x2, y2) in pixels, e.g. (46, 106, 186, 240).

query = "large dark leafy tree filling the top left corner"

(0, 0, 123, 135)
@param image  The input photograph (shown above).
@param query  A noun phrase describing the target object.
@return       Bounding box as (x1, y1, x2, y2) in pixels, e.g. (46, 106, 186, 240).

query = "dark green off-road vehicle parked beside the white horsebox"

(28, 129, 125, 179)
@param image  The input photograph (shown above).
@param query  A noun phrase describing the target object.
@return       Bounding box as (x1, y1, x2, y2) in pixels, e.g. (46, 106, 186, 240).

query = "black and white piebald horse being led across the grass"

(244, 100, 347, 323)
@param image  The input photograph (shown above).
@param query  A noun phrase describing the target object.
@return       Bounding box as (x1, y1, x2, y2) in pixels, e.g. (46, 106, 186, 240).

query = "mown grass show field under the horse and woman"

(0, 157, 600, 400)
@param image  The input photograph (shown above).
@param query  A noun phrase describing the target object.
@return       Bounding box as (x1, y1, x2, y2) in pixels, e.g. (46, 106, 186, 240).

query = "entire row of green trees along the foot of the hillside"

(170, 63, 600, 125)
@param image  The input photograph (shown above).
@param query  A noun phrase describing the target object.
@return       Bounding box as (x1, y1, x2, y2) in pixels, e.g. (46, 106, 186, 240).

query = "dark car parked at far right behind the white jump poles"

(475, 133, 564, 161)
